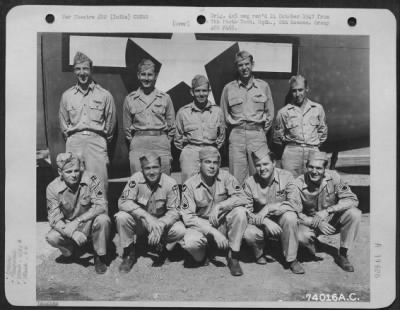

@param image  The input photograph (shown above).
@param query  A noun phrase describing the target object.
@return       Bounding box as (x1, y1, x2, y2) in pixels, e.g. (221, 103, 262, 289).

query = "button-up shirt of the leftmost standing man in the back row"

(59, 82, 117, 142)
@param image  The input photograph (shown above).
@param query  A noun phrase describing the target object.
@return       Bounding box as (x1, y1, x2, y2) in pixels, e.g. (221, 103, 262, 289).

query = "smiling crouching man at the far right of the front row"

(286, 151, 361, 272)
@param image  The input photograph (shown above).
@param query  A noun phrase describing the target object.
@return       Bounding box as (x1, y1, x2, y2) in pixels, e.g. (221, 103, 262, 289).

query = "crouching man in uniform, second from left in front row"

(115, 152, 185, 273)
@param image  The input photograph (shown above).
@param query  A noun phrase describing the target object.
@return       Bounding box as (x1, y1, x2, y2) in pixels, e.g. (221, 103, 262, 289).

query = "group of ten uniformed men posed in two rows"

(46, 51, 361, 276)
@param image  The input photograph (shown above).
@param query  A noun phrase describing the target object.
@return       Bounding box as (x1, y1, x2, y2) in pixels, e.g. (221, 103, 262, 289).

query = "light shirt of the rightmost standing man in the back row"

(273, 99, 328, 146)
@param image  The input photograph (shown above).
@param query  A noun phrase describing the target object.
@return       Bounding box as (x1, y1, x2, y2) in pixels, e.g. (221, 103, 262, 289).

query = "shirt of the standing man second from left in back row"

(122, 88, 175, 141)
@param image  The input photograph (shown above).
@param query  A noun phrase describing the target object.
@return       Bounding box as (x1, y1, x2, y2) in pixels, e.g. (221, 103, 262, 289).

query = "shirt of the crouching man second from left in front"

(118, 172, 180, 227)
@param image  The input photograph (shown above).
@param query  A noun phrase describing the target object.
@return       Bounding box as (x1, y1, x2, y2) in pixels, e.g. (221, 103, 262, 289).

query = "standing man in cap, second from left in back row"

(122, 59, 175, 175)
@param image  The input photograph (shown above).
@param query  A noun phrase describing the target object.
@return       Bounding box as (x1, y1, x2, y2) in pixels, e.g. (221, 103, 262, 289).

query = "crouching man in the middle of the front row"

(181, 146, 248, 276)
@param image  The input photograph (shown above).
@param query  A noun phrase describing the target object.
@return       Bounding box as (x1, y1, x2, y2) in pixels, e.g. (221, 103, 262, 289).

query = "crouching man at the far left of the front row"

(46, 153, 111, 274)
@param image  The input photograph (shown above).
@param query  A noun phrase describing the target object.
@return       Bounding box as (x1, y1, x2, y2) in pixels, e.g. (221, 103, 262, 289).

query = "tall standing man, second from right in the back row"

(220, 51, 274, 184)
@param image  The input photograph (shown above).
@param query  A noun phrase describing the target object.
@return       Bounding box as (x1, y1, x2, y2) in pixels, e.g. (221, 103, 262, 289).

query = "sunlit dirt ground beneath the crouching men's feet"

(37, 214, 370, 302)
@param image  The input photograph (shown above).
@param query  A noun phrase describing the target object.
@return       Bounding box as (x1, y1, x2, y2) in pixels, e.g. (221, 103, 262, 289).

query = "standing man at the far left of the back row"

(59, 52, 116, 195)
